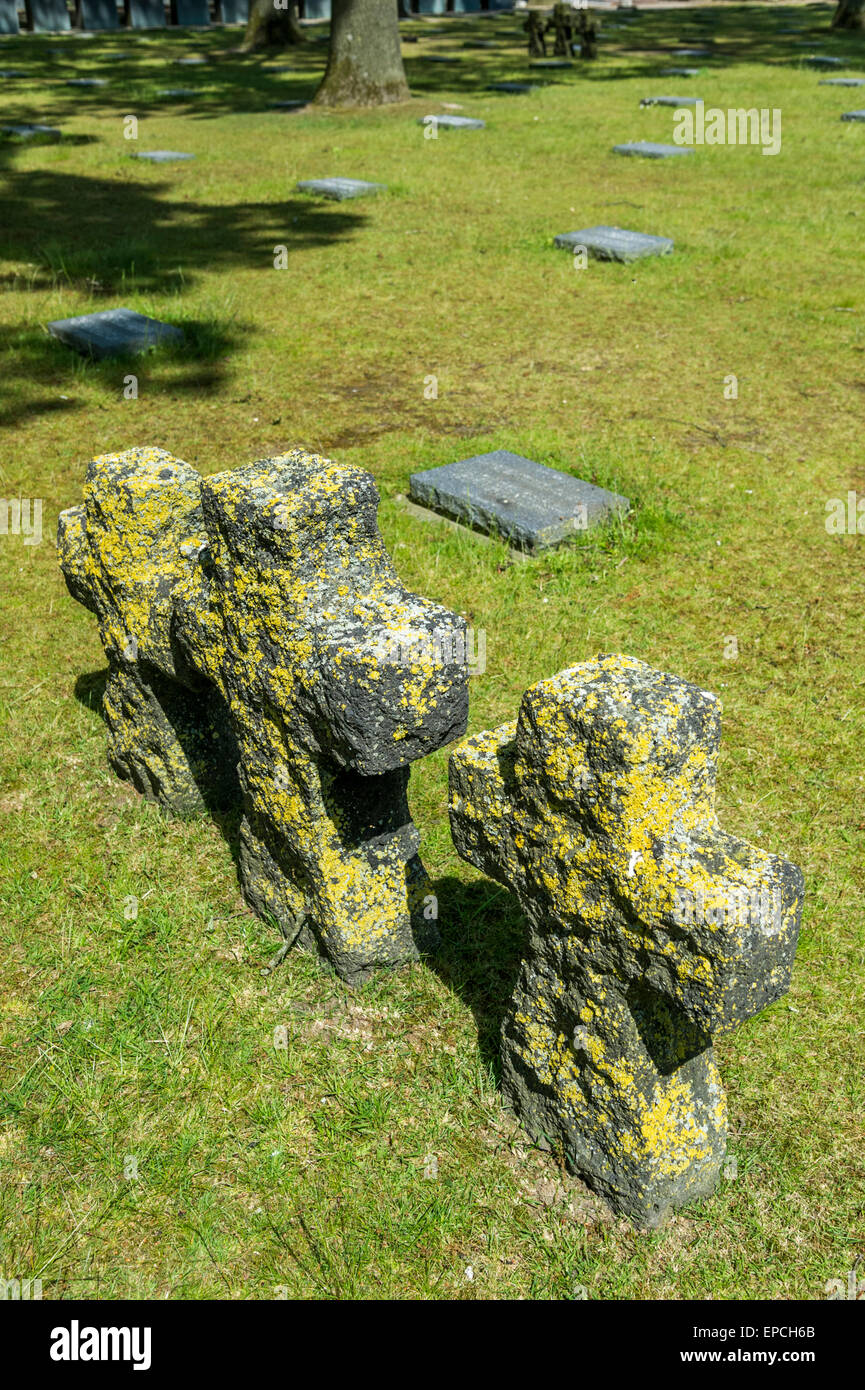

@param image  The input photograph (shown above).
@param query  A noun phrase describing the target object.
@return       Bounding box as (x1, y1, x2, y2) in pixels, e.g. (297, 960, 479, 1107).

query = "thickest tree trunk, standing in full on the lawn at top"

(313, 0, 410, 106)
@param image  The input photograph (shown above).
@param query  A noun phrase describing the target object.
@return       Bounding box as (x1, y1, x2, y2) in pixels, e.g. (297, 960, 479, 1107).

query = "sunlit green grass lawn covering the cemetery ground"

(0, 6, 865, 1300)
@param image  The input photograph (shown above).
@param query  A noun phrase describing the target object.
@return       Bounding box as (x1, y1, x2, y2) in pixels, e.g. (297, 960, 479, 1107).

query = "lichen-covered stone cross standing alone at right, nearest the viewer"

(451, 656, 804, 1227)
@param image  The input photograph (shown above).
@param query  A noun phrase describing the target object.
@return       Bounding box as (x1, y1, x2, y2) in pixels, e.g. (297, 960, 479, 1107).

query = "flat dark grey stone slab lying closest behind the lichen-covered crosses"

(409, 449, 629, 550)
